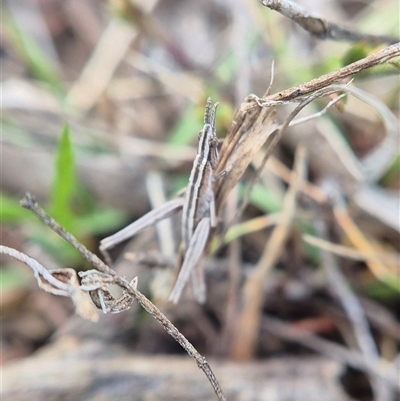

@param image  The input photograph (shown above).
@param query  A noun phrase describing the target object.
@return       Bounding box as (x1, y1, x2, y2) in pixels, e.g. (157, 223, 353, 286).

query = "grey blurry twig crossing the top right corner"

(259, 0, 399, 44)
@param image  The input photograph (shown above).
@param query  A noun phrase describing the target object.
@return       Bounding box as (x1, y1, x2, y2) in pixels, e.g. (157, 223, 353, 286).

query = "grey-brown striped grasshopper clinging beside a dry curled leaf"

(100, 98, 219, 303)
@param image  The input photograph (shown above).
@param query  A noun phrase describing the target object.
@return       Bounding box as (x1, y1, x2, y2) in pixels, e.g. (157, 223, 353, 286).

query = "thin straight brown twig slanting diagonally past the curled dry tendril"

(21, 194, 226, 401)
